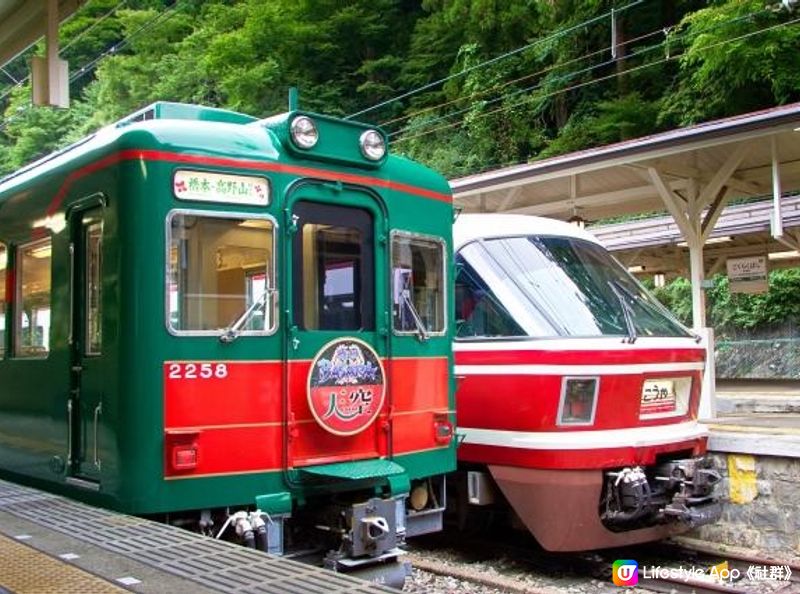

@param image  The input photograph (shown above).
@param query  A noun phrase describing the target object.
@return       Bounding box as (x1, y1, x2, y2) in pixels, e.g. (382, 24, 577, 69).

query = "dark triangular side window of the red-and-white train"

(456, 256, 526, 338)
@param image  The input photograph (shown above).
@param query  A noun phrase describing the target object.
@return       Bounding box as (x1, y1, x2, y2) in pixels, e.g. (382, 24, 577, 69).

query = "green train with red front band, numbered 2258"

(0, 103, 456, 584)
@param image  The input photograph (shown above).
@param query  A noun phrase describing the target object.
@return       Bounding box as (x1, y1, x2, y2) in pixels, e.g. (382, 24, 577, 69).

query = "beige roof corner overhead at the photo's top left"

(0, 0, 86, 67)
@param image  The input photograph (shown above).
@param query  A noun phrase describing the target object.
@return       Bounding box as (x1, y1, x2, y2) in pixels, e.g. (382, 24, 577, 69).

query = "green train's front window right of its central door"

(392, 233, 447, 333)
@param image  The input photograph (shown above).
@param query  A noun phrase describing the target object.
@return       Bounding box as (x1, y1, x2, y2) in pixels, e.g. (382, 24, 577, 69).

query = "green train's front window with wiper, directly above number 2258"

(167, 212, 277, 335)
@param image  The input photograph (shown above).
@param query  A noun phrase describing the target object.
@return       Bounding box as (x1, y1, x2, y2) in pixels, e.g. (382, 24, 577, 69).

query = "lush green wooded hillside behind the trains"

(0, 0, 800, 176)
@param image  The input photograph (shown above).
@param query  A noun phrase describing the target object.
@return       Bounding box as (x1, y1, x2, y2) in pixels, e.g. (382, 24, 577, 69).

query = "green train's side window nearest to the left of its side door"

(14, 238, 53, 357)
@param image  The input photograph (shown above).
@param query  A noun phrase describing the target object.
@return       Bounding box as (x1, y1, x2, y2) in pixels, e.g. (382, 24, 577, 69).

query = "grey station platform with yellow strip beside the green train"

(0, 480, 398, 594)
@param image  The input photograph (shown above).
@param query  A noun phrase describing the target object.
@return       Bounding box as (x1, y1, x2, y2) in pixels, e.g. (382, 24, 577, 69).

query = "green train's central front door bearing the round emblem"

(286, 192, 390, 468)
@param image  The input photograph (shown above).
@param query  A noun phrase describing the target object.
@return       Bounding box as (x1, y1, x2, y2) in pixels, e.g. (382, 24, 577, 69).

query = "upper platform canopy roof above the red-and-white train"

(450, 103, 800, 221)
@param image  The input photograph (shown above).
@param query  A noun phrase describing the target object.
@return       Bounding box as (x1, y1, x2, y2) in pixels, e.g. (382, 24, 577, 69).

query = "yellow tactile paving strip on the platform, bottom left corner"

(0, 535, 128, 594)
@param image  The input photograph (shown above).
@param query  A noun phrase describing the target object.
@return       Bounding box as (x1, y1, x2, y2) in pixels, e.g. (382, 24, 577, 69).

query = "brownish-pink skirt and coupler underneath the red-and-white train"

(450, 458, 721, 552)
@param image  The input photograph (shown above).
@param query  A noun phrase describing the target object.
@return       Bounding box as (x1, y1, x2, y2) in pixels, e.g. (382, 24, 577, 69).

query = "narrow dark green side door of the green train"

(67, 208, 103, 485)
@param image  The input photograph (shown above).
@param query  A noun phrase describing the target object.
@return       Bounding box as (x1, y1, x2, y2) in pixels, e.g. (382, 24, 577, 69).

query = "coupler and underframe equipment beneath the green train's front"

(166, 476, 446, 588)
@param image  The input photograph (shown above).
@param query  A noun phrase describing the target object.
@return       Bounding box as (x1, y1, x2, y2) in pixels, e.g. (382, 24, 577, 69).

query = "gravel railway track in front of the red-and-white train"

(409, 533, 800, 594)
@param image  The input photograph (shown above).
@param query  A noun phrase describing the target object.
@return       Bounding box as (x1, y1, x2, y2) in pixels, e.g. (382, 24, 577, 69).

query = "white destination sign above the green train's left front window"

(172, 169, 269, 206)
